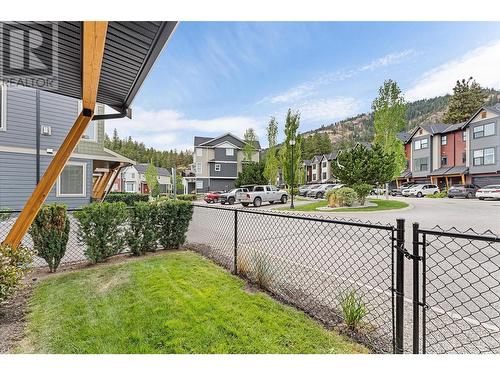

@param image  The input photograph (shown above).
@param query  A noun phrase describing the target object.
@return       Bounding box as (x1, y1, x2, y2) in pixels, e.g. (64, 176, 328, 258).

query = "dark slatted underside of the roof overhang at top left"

(0, 21, 177, 112)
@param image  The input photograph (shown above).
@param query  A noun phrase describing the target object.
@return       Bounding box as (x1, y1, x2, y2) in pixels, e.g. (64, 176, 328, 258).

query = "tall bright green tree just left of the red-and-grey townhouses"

(372, 79, 406, 182)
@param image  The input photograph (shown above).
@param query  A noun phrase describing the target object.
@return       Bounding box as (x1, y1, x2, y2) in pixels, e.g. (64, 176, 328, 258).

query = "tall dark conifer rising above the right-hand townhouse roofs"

(443, 77, 487, 124)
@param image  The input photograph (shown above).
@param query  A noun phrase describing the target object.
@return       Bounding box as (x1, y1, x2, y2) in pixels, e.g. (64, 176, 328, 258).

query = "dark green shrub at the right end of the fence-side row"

(156, 200, 193, 249)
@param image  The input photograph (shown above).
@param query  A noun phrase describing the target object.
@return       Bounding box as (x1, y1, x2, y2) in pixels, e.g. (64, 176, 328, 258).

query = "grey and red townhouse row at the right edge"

(396, 105, 500, 188)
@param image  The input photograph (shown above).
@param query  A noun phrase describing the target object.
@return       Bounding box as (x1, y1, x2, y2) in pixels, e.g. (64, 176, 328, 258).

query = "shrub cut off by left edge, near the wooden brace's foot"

(0, 244, 34, 302)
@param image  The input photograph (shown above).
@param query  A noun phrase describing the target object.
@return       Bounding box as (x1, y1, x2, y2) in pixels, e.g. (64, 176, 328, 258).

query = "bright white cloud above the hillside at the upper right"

(405, 40, 500, 101)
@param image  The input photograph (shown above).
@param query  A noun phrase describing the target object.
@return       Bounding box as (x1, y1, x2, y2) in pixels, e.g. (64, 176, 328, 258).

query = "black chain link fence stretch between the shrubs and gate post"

(187, 205, 394, 352)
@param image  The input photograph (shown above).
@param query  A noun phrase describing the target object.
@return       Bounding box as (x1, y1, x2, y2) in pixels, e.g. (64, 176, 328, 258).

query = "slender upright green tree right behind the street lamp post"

(280, 109, 302, 189)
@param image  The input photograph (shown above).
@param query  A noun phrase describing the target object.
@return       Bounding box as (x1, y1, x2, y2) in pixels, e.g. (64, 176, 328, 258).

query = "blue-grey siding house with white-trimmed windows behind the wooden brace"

(0, 84, 134, 210)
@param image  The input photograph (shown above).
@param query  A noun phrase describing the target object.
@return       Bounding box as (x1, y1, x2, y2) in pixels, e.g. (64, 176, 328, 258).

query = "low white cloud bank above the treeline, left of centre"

(106, 107, 265, 150)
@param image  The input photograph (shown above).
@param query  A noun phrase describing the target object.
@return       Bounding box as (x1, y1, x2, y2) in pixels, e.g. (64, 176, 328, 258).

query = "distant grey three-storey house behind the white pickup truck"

(191, 133, 260, 193)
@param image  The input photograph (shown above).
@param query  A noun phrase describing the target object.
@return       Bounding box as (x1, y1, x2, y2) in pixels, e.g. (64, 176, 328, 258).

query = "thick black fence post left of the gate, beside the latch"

(396, 219, 405, 354)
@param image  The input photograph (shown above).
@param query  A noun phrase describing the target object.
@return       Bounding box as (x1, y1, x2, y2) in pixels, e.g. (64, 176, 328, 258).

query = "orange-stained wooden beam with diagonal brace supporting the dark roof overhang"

(4, 22, 108, 247)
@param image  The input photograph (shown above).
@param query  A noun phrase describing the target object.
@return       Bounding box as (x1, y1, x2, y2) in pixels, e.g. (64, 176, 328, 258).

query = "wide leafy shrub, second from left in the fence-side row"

(75, 202, 127, 264)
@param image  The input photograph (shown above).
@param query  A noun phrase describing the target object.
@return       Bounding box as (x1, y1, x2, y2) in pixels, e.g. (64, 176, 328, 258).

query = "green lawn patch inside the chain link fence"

(16, 251, 367, 353)
